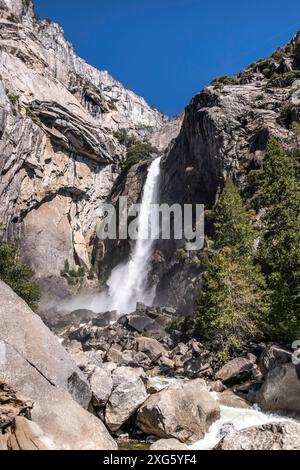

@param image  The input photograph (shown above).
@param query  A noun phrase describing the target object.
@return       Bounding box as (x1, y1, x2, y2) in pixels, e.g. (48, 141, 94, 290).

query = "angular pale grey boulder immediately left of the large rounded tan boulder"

(105, 367, 148, 431)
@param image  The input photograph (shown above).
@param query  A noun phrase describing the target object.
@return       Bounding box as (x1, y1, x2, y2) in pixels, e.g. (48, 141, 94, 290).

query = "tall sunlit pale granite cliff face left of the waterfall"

(0, 0, 168, 296)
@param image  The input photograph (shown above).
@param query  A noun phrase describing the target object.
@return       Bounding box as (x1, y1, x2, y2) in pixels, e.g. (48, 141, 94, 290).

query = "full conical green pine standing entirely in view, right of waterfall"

(197, 180, 268, 357)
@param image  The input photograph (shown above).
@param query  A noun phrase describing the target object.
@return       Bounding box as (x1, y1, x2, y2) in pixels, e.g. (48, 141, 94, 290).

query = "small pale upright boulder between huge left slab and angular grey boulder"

(89, 367, 114, 407)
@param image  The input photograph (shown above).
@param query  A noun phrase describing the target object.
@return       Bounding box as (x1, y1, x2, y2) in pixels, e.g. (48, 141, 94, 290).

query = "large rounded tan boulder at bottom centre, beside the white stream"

(137, 379, 220, 442)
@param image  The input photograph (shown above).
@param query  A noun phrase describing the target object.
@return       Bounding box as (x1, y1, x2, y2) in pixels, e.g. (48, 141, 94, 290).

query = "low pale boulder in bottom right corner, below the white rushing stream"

(215, 422, 300, 450)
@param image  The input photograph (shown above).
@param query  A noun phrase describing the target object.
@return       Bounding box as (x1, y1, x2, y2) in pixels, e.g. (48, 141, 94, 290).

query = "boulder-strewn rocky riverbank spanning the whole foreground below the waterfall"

(0, 283, 300, 450)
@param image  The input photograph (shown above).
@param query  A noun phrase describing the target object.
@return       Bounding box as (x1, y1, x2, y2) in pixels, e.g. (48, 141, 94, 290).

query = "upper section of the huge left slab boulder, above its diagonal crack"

(0, 281, 91, 408)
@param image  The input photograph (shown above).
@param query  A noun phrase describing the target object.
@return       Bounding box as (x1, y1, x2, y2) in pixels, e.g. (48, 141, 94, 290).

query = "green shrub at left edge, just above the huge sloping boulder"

(0, 243, 40, 310)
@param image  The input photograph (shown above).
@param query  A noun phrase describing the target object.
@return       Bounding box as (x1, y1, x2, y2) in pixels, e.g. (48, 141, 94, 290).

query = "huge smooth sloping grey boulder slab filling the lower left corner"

(0, 281, 116, 450)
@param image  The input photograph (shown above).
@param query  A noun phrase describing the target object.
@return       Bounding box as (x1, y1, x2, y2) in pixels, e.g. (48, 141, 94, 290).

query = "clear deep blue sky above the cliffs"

(35, 0, 300, 115)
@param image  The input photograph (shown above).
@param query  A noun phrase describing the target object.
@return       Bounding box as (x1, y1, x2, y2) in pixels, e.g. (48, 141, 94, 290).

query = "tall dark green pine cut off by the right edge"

(259, 139, 300, 344)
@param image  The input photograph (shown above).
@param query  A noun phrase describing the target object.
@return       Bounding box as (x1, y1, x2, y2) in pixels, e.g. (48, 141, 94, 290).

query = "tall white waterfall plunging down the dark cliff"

(102, 158, 161, 313)
